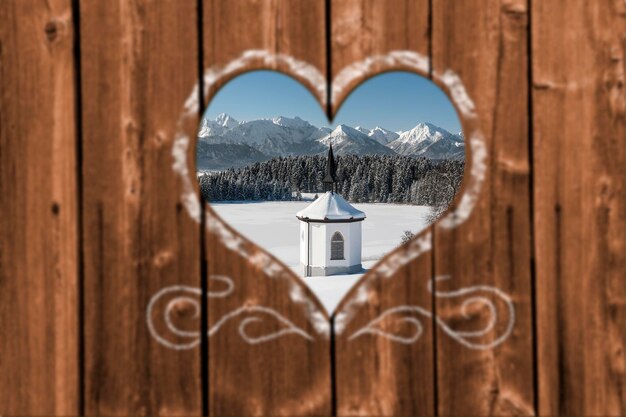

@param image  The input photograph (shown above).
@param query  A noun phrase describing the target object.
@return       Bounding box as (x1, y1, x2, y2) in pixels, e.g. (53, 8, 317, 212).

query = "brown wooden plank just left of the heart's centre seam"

(203, 0, 331, 416)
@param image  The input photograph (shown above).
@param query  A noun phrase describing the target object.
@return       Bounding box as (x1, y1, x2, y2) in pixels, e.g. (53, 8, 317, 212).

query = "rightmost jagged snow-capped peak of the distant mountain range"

(388, 123, 465, 159)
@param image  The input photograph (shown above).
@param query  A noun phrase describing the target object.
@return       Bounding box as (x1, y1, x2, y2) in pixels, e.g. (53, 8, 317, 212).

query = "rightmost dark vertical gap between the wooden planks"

(526, 0, 539, 415)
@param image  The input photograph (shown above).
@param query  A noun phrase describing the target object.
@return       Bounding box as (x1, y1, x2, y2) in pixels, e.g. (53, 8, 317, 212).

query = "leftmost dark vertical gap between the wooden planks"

(71, 0, 85, 416)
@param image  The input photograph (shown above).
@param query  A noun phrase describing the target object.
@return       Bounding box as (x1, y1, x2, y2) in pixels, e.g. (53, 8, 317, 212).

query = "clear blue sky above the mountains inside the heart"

(205, 71, 461, 133)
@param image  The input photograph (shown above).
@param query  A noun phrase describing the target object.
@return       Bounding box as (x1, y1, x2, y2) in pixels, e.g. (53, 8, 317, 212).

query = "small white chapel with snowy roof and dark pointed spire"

(296, 144, 365, 277)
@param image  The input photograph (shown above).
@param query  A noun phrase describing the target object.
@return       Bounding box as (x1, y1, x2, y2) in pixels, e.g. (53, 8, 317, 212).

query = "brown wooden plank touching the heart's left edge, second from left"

(80, 0, 202, 415)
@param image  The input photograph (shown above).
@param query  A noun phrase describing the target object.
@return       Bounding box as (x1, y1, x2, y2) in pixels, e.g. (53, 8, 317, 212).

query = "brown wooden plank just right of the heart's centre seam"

(331, 0, 435, 416)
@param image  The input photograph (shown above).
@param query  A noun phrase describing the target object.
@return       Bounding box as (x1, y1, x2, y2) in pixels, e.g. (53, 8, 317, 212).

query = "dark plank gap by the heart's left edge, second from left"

(192, 0, 209, 416)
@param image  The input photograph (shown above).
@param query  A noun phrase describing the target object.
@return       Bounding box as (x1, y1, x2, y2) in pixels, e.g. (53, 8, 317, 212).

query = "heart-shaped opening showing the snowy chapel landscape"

(196, 71, 465, 314)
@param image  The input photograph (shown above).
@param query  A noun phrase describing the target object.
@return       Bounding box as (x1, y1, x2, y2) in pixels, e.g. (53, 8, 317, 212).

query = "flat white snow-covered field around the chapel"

(212, 196, 430, 313)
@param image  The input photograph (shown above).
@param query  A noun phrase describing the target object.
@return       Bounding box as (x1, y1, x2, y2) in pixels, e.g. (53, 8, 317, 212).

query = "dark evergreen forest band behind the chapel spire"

(198, 155, 465, 206)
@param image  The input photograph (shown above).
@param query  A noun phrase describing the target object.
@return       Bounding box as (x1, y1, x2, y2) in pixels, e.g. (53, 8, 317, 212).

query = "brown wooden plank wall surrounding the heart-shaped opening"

(0, 0, 626, 416)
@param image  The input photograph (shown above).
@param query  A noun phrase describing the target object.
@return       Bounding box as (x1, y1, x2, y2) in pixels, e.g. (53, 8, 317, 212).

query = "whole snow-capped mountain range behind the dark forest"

(196, 113, 465, 170)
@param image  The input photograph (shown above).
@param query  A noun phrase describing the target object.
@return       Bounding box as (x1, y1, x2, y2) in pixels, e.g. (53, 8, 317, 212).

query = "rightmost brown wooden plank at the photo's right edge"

(531, 1, 626, 416)
